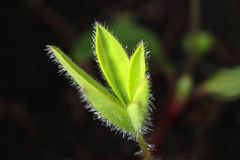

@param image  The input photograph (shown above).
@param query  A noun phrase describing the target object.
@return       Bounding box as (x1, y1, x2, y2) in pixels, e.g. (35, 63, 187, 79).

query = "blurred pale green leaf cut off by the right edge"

(202, 67, 240, 101)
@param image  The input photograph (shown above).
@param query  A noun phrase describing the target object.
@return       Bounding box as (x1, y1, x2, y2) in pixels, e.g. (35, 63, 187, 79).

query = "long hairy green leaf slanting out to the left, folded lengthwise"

(48, 46, 135, 133)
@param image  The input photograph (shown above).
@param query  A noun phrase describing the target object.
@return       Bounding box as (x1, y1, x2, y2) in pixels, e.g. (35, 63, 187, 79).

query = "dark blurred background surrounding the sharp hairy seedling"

(0, 0, 240, 160)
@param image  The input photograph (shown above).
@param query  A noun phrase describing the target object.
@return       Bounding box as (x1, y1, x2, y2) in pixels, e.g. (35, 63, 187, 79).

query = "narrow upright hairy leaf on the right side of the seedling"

(128, 42, 149, 133)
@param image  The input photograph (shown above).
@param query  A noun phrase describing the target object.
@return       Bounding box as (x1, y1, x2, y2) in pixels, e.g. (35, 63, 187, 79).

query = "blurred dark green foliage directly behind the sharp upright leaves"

(72, 15, 162, 62)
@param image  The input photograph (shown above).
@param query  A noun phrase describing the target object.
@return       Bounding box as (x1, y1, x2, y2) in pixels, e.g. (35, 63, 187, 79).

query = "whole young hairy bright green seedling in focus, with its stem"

(47, 23, 152, 160)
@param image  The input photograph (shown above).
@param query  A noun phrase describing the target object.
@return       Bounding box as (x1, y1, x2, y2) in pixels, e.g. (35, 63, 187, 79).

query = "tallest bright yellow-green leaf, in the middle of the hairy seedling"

(95, 23, 129, 106)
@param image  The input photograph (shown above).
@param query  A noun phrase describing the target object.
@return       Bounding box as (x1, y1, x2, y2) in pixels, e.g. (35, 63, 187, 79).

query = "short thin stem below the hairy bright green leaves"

(137, 136, 153, 160)
